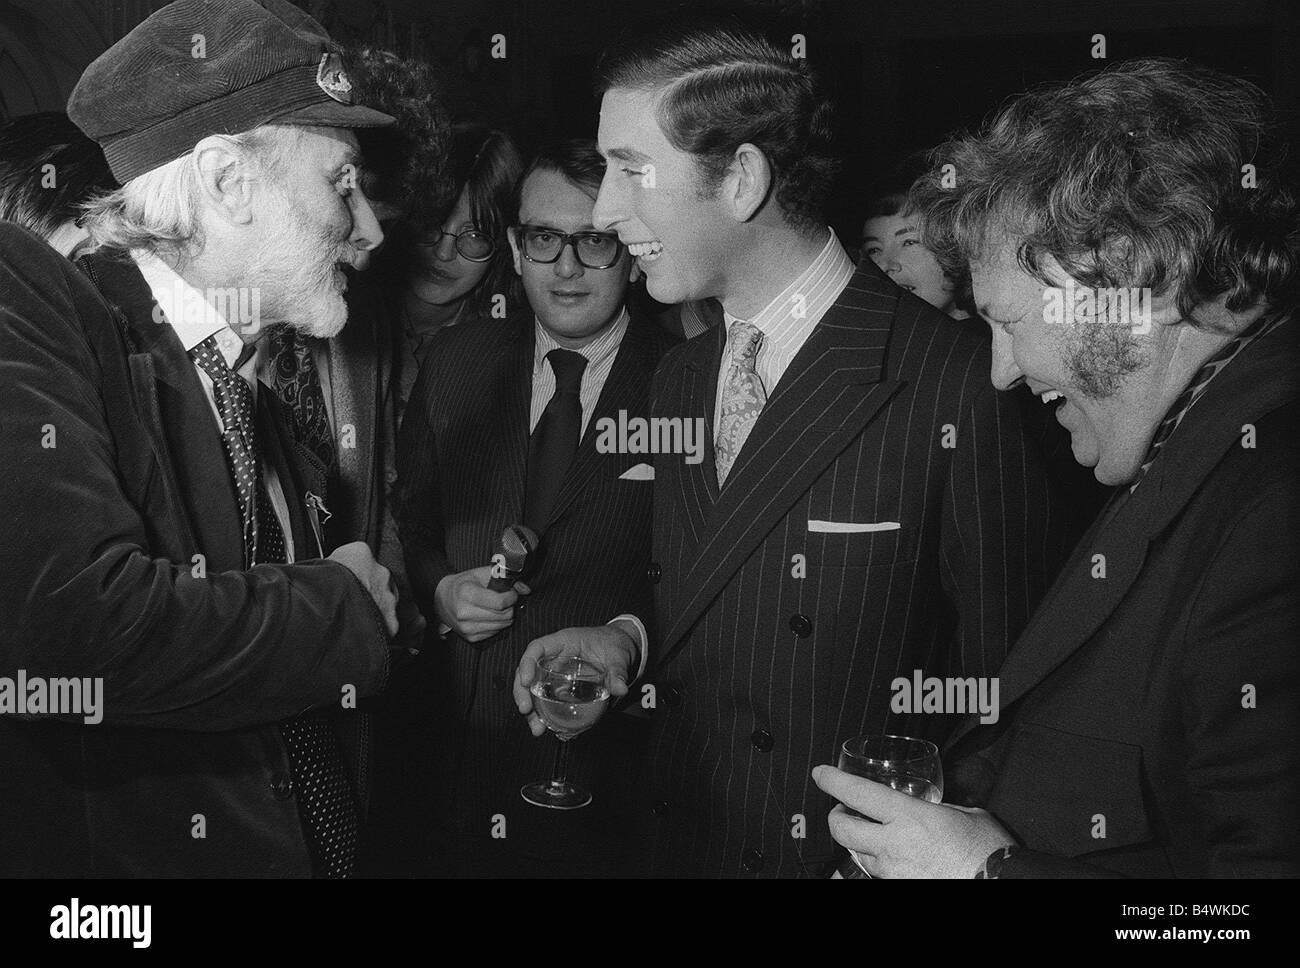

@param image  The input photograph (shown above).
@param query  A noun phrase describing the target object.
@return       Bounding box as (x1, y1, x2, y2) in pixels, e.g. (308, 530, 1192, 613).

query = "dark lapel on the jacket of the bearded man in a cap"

(82, 253, 243, 570)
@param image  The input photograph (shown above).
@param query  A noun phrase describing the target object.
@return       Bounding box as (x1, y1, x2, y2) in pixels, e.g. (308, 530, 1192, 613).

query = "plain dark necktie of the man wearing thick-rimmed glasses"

(524, 350, 586, 533)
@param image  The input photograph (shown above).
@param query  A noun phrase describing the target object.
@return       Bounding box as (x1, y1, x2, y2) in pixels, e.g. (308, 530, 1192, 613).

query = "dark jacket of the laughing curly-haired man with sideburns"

(944, 320, 1300, 877)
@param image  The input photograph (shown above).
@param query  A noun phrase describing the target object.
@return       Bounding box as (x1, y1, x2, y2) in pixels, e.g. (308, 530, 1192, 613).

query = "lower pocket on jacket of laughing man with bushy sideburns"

(988, 722, 1152, 858)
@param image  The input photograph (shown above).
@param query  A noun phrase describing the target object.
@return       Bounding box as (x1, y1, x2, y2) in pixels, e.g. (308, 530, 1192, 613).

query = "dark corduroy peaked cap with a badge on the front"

(68, 0, 394, 185)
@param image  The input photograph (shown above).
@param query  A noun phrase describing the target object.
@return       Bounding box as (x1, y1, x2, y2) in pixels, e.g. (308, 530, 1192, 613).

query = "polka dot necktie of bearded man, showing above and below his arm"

(190, 337, 358, 878)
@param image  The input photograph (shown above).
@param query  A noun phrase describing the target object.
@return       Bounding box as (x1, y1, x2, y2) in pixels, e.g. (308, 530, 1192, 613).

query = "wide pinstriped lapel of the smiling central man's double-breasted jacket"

(660, 287, 902, 661)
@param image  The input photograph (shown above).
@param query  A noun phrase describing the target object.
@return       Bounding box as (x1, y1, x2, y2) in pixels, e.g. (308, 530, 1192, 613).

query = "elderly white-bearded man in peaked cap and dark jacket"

(0, 0, 413, 877)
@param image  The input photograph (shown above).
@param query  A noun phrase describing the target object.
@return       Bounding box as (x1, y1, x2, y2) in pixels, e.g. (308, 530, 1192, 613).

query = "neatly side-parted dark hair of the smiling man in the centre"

(595, 16, 839, 229)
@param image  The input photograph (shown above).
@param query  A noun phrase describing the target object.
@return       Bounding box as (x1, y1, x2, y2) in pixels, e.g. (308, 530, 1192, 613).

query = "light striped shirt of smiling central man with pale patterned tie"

(714, 229, 854, 429)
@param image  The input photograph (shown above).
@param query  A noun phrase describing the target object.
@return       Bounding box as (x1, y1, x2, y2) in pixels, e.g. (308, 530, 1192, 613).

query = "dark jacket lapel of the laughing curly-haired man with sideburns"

(948, 320, 1300, 747)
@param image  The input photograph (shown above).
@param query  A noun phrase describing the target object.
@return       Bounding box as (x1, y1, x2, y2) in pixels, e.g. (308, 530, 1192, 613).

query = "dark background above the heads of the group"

(0, 0, 1300, 243)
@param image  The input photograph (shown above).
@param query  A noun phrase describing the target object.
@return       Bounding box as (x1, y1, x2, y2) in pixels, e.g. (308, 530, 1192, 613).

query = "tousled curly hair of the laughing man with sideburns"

(911, 57, 1300, 325)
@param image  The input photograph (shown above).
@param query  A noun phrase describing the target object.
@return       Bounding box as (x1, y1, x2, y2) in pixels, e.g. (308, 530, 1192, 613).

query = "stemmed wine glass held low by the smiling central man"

(519, 655, 610, 809)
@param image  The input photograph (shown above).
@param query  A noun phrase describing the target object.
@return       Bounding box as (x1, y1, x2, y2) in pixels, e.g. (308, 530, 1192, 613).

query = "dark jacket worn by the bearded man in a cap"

(0, 223, 389, 877)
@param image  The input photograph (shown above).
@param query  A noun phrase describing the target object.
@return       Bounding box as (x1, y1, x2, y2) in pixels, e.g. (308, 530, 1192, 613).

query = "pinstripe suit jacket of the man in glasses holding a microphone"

(398, 313, 675, 876)
